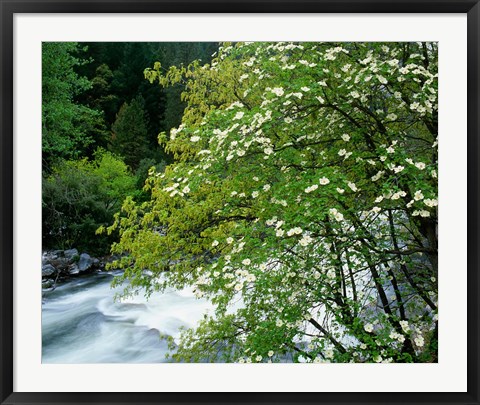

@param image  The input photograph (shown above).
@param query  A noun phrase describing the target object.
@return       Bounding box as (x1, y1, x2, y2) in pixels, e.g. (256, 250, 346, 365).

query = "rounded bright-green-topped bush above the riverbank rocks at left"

(42, 150, 136, 254)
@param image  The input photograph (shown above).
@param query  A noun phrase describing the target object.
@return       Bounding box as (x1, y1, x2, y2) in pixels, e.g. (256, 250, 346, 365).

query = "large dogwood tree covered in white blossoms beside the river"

(103, 42, 438, 362)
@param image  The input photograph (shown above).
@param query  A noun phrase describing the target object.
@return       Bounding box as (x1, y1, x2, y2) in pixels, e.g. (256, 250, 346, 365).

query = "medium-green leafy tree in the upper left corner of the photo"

(42, 42, 104, 171)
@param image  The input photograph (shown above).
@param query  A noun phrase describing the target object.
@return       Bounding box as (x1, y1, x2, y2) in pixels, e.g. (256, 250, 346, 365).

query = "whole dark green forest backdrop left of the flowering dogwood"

(42, 42, 218, 253)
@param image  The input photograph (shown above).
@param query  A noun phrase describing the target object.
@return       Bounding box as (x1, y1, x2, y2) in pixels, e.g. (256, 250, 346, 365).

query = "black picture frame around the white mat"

(0, 0, 480, 404)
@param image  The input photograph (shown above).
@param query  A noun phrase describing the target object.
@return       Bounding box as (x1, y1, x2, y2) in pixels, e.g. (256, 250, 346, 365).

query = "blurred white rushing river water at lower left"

(42, 273, 213, 363)
